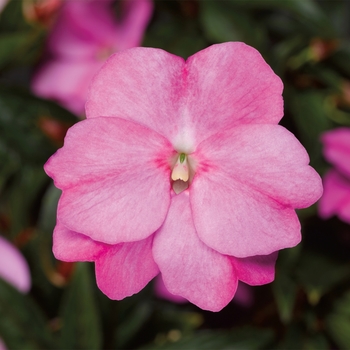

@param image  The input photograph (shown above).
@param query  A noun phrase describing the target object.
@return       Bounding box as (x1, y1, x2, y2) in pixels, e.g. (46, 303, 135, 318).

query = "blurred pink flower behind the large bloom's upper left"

(32, 0, 152, 115)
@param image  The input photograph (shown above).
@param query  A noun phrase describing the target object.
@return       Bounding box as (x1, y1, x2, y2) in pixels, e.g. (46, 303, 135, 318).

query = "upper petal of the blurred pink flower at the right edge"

(321, 128, 350, 177)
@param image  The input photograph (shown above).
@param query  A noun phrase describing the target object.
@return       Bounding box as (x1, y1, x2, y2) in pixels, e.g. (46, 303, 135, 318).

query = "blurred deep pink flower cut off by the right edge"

(319, 127, 350, 223)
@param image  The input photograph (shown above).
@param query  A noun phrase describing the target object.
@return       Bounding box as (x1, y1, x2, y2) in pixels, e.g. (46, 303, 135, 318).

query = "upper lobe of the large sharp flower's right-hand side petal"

(193, 125, 322, 208)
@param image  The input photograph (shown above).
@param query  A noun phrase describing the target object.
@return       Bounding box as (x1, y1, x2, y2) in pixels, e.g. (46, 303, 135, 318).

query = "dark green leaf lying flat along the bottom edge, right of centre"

(145, 327, 273, 350)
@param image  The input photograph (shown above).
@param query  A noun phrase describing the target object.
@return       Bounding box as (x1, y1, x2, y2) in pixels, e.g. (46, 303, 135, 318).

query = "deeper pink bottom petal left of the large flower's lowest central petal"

(95, 236, 159, 300)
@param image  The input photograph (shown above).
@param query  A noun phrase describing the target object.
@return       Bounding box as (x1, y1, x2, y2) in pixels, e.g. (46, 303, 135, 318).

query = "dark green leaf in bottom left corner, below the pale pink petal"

(0, 279, 55, 350)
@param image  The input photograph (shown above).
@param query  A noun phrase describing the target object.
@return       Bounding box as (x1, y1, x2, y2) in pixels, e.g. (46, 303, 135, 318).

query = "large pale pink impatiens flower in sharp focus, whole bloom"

(45, 42, 322, 311)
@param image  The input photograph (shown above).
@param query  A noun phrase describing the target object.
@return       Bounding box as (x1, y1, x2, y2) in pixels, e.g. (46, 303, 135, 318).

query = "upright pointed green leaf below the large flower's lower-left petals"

(60, 263, 102, 349)
